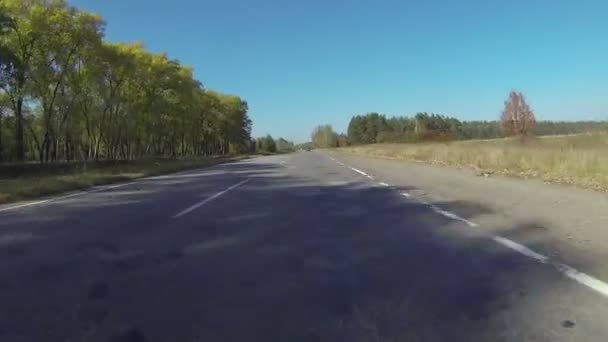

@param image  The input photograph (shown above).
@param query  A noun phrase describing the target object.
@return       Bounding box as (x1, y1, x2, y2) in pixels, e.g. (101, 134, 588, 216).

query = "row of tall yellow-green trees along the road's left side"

(0, 0, 251, 163)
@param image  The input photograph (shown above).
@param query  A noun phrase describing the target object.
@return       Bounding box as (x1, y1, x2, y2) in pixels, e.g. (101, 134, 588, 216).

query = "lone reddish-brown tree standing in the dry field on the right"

(500, 91, 536, 136)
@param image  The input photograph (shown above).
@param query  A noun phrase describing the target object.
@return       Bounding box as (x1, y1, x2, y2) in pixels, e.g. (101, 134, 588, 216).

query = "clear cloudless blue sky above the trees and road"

(70, 0, 608, 141)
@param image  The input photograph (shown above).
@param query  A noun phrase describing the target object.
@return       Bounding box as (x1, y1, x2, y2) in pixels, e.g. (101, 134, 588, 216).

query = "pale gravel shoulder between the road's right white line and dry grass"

(333, 152, 608, 280)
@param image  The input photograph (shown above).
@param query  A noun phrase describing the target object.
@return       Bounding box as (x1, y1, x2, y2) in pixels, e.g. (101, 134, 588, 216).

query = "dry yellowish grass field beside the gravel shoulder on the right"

(341, 133, 608, 191)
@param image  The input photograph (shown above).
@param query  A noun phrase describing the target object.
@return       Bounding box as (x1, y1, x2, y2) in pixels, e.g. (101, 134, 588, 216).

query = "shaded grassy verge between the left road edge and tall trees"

(0, 156, 246, 204)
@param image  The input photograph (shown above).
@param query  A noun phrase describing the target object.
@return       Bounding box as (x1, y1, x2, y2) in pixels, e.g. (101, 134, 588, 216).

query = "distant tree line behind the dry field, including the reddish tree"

(312, 91, 608, 147)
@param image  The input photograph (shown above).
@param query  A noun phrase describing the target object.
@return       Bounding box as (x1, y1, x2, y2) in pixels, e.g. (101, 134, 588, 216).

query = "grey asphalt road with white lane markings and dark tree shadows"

(0, 152, 608, 342)
